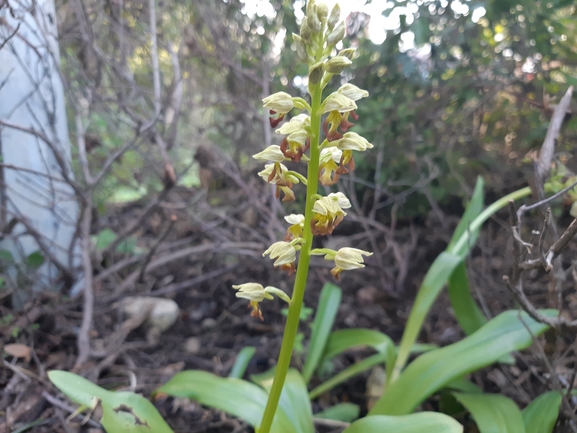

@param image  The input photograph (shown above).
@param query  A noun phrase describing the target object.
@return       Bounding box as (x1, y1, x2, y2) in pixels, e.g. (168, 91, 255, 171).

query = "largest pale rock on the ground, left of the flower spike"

(120, 296, 180, 332)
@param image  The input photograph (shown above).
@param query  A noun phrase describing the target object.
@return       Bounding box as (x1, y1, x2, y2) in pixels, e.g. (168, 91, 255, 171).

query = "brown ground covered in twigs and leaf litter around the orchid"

(0, 176, 575, 433)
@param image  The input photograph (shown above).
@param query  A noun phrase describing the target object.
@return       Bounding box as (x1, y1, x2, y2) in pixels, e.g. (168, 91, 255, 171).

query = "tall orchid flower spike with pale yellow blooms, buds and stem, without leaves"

(233, 1, 373, 433)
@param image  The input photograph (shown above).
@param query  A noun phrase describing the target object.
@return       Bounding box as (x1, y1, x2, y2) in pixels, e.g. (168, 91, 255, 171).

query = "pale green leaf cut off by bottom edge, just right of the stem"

(343, 412, 463, 433)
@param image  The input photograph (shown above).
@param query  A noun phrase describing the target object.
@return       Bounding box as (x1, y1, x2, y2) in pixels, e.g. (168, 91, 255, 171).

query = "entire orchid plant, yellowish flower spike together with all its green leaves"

(49, 0, 561, 433)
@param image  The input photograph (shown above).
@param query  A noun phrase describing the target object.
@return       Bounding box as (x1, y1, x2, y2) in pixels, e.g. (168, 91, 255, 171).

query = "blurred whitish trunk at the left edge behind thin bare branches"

(0, 0, 78, 306)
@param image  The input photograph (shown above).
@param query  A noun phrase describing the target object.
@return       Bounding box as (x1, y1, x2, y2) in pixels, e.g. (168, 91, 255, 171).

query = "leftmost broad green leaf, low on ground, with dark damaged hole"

(48, 370, 172, 433)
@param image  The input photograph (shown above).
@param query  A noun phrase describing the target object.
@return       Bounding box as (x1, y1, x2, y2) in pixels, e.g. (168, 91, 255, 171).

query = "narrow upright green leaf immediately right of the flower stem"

(302, 283, 343, 383)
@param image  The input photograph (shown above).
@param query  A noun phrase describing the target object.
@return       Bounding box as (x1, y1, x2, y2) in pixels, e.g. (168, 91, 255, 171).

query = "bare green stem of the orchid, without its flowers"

(256, 67, 322, 433)
